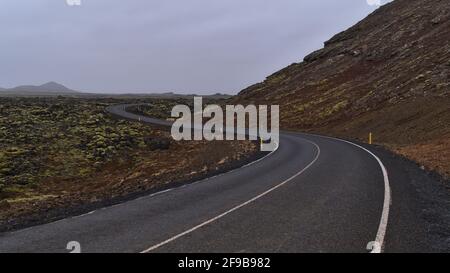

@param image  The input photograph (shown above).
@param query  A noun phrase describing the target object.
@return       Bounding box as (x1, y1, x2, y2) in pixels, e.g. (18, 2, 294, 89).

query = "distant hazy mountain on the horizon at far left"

(0, 82, 79, 95)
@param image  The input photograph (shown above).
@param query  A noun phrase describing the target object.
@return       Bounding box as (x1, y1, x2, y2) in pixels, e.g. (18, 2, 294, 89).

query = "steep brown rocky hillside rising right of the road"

(235, 0, 450, 175)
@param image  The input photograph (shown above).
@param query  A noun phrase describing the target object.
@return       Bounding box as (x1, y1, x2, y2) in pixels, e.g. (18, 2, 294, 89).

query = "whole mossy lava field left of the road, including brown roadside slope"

(0, 97, 260, 231)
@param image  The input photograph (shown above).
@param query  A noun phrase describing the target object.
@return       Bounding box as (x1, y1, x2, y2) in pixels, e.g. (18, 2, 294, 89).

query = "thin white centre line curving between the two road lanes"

(141, 140, 320, 253)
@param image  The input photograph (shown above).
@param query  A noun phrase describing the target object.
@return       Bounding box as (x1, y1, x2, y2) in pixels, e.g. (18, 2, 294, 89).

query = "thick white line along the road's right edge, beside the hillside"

(300, 133, 392, 254)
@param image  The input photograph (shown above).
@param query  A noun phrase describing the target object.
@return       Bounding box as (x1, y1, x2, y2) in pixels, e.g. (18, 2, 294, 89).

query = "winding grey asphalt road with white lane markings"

(0, 105, 442, 253)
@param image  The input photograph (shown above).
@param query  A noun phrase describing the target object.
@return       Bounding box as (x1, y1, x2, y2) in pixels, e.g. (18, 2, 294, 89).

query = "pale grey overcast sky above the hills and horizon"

(0, 0, 384, 94)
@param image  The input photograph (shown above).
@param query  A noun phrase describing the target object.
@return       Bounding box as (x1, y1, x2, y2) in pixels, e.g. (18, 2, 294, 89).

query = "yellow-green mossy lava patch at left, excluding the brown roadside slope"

(0, 98, 169, 197)
